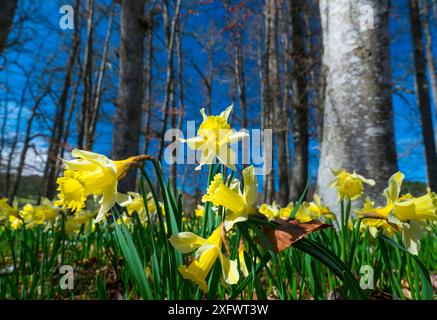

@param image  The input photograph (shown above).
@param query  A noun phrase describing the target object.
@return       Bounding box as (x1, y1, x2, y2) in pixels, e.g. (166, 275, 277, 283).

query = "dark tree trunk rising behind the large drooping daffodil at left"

(112, 0, 145, 192)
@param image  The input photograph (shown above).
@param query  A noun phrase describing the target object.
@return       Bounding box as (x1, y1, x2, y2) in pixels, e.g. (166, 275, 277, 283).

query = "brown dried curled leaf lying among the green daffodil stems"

(257, 219, 332, 253)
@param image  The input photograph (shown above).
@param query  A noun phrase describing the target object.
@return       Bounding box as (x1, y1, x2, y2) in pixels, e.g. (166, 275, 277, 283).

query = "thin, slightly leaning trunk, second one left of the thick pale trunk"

(267, 0, 289, 206)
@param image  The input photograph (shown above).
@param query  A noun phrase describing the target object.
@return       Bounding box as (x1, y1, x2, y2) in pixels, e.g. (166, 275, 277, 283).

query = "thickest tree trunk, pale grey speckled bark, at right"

(317, 0, 397, 209)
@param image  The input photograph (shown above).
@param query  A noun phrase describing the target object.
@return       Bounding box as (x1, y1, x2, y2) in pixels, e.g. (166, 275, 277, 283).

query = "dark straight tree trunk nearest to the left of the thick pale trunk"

(290, 0, 308, 201)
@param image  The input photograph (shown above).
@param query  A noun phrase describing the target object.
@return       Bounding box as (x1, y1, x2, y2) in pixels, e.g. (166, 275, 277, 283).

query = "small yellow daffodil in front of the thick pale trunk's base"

(330, 169, 375, 200)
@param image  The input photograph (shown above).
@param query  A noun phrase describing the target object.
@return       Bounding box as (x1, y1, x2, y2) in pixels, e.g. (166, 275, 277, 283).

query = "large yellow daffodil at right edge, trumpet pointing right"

(357, 172, 437, 255)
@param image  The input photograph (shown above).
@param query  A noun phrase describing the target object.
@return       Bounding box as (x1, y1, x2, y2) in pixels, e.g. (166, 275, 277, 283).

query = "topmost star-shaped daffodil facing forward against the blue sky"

(180, 105, 248, 170)
